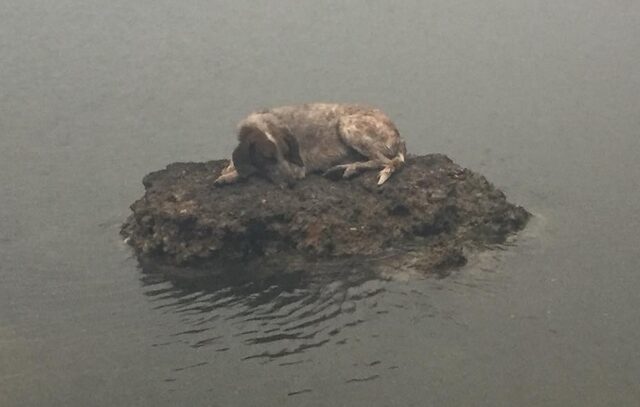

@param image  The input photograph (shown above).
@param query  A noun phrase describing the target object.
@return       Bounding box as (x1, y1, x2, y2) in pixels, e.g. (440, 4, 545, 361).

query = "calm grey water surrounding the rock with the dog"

(0, 0, 640, 407)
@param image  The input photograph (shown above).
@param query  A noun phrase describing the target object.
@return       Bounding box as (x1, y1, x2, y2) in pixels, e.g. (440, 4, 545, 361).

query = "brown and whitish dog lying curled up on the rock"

(215, 103, 406, 185)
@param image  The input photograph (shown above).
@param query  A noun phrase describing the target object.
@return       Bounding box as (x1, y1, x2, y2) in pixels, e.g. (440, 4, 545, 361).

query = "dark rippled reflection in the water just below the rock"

(142, 264, 386, 365)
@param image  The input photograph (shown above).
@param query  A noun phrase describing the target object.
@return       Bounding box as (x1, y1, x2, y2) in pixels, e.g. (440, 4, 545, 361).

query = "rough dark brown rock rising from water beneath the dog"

(122, 154, 530, 282)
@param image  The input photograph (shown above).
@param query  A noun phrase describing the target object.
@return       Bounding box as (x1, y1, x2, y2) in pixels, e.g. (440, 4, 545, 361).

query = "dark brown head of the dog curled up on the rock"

(233, 126, 304, 184)
